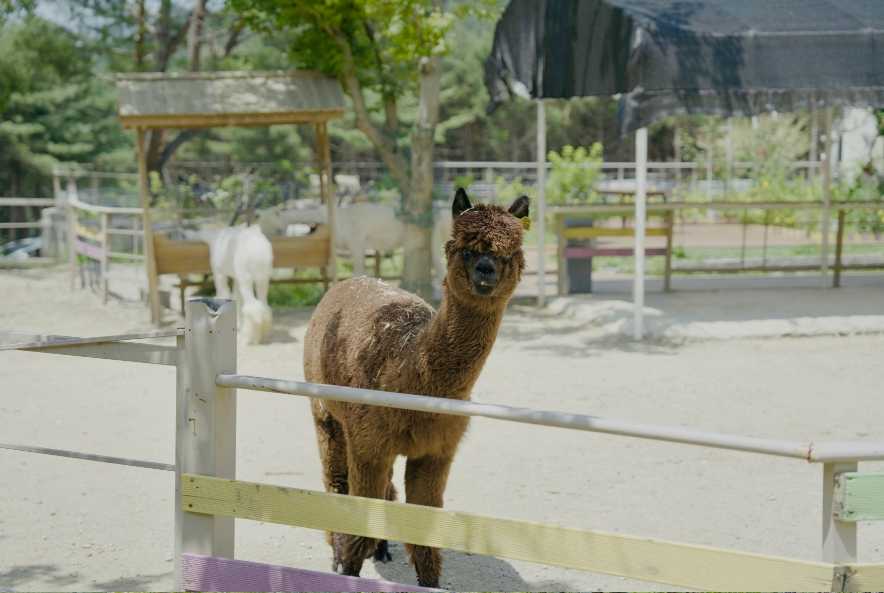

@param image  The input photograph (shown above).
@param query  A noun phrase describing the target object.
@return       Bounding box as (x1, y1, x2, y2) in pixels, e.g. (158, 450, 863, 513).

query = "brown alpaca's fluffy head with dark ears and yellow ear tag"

(445, 188, 528, 304)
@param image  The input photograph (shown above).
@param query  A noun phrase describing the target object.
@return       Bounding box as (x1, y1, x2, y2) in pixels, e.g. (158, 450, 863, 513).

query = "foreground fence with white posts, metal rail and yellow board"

(0, 299, 884, 591)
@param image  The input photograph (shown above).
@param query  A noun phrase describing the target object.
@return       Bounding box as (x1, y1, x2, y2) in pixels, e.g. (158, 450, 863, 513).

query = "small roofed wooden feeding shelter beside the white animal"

(116, 71, 344, 323)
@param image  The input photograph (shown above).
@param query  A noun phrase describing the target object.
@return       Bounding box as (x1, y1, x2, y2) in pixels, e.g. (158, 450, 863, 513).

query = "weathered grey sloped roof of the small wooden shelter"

(116, 70, 344, 128)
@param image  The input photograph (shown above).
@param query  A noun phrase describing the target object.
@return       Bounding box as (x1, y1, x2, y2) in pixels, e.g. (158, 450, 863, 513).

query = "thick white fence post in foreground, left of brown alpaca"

(174, 298, 236, 591)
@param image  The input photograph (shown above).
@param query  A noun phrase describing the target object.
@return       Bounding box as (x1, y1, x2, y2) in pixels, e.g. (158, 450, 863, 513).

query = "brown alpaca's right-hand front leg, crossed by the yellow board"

(405, 456, 452, 587)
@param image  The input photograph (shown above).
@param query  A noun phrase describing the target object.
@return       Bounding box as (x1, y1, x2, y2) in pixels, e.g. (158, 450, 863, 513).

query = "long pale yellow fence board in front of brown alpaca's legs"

(181, 474, 833, 591)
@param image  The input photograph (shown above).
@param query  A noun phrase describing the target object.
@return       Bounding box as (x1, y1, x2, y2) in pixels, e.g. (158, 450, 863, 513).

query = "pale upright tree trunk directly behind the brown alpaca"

(402, 57, 440, 299)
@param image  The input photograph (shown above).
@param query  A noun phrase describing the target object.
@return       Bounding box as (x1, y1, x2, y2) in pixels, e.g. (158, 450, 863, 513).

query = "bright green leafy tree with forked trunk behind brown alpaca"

(230, 0, 498, 296)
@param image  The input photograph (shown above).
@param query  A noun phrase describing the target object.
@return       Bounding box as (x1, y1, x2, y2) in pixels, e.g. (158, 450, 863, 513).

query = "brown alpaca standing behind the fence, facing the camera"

(304, 189, 528, 587)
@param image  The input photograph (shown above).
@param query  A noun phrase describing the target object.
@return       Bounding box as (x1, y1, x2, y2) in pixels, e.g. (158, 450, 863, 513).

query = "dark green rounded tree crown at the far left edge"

(0, 16, 127, 195)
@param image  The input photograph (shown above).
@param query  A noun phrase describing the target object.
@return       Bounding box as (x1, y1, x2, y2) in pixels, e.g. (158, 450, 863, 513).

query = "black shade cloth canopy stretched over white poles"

(485, 0, 884, 132)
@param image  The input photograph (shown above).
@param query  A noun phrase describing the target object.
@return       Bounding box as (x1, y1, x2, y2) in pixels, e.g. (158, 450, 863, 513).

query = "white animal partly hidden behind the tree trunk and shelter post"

(262, 202, 451, 283)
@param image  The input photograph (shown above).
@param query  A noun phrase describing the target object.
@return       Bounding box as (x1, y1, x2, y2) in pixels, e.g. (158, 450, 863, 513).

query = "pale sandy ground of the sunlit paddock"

(0, 270, 884, 591)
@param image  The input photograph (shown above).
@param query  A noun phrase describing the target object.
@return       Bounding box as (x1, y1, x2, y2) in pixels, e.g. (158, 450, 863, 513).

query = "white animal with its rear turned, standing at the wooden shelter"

(203, 226, 273, 344)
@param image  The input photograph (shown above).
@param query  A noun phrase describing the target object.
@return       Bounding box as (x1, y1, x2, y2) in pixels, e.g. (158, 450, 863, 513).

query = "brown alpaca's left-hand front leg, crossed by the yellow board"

(333, 454, 393, 576)
